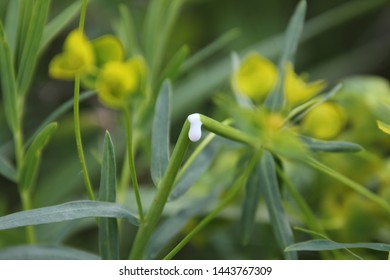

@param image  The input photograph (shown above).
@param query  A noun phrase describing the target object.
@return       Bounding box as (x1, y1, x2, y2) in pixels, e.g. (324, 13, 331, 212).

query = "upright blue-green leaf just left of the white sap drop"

(151, 81, 172, 186)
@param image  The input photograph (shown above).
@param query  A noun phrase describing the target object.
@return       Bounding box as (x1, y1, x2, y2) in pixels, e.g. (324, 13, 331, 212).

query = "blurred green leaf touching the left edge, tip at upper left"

(0, 22, 19, 131)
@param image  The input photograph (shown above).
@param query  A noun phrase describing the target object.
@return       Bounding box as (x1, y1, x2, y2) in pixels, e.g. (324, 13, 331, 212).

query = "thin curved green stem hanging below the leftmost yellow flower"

(73, 75, 95, 200)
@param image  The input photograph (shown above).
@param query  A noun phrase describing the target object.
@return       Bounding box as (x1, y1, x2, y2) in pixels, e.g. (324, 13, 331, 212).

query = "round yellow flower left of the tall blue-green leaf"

(233, 53, 278, 101)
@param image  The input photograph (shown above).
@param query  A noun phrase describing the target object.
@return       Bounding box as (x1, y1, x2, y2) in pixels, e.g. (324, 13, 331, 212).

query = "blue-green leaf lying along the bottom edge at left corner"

(0, 245, 100, 260)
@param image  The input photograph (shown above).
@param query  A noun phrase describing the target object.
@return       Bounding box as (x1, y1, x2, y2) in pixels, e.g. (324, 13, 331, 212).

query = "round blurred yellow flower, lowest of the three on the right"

(301, 102, 346, 140)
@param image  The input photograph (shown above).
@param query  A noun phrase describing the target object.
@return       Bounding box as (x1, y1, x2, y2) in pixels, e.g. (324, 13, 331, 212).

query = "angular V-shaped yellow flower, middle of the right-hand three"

(284, 63, 326, 106)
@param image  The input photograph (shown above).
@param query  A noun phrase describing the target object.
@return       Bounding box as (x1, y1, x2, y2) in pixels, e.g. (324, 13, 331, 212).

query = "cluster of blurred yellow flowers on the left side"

(49, 30, 146, 109)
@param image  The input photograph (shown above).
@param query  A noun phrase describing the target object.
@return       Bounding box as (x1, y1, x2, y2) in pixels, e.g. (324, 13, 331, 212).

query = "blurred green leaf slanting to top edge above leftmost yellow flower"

(39, 1, 81, 52)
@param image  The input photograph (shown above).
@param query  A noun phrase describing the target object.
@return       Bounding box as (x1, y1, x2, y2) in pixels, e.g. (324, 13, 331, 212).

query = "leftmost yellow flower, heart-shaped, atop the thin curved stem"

(49, 30, 95, 80)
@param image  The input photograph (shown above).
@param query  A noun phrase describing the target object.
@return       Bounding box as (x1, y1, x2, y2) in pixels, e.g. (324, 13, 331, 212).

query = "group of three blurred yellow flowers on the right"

(232, 53, 346, 140)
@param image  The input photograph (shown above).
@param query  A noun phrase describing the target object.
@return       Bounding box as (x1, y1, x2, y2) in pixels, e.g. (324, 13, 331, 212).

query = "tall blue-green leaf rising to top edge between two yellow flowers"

(264, 0, 306, 111)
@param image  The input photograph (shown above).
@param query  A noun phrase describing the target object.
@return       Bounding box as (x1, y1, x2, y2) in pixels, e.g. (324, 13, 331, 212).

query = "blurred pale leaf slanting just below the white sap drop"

(169, 143, 219, 201)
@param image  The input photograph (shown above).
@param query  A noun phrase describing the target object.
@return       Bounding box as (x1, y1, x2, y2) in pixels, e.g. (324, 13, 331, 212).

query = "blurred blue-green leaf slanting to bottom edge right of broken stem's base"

(146, 191, 222, 259)
